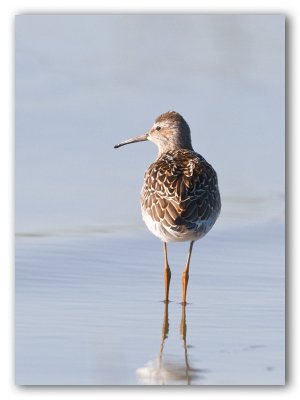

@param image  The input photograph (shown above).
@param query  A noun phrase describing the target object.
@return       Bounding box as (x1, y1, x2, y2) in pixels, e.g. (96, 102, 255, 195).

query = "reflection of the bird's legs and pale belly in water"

(136, 302, 206, 385)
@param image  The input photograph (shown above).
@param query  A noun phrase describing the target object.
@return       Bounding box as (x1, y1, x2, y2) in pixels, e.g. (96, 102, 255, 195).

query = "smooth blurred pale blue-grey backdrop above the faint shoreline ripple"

(15, 15, 285, 234)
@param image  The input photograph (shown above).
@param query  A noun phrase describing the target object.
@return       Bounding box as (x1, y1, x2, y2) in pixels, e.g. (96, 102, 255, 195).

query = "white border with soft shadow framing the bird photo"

(0, 0, 300, 400)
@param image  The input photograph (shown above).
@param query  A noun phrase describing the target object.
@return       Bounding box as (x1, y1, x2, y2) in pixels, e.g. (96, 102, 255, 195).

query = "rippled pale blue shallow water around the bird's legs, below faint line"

(16, 222, 284, 385)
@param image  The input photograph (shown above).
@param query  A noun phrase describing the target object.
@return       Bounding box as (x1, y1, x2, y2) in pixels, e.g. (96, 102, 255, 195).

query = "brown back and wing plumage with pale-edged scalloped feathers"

(141, 150, 221, 230)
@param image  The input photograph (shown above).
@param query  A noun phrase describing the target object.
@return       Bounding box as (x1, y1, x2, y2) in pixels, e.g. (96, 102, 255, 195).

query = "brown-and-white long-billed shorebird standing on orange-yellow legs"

(114, 111, 221, 305)
